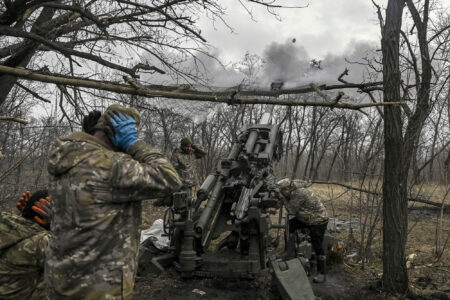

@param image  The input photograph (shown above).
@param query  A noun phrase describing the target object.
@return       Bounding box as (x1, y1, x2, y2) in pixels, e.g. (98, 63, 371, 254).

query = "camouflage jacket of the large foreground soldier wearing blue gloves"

(45, 132, 181, 299)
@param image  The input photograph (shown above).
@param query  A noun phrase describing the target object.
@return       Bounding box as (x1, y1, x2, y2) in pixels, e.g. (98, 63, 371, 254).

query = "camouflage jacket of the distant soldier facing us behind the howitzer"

(171, 144, 206, 187)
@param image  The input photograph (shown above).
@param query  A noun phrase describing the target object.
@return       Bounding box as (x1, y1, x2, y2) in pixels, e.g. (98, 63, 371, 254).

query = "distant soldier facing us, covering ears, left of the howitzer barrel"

(171, 137, 206, 196)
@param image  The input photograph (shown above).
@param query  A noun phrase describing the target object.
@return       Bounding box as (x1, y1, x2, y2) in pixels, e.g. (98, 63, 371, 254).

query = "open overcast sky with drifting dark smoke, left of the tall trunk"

(190, 0, 450, 86)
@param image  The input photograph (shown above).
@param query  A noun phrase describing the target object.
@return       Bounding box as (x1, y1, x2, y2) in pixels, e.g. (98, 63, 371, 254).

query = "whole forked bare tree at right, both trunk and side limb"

(380, 0, 448, 293)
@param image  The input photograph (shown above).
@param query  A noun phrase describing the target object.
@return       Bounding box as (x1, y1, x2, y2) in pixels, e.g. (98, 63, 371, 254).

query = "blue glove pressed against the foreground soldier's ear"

(108, 112, 138, 151)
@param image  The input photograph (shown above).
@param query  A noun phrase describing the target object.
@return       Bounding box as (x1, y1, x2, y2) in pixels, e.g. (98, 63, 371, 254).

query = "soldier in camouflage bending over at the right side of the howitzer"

(277, 178, 328, 283)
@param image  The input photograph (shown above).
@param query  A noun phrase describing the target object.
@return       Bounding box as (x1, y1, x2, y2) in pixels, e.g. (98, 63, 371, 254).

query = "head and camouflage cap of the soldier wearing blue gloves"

(94, 104, 141, 149)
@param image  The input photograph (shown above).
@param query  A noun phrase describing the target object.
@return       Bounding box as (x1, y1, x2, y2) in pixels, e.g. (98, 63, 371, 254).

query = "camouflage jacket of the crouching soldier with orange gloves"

(0, 212, 50, 299)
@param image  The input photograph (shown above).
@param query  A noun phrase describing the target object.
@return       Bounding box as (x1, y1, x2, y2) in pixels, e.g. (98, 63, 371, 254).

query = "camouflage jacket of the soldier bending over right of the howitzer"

(285, 187, 328, 225)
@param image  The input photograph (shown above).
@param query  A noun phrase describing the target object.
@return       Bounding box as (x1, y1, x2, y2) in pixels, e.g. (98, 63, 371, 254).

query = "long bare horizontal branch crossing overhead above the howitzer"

(0, 65, 401, 110)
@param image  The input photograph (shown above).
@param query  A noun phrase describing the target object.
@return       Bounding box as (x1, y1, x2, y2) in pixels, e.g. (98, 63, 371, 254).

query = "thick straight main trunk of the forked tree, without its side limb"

(381, 0, 408, 293)
